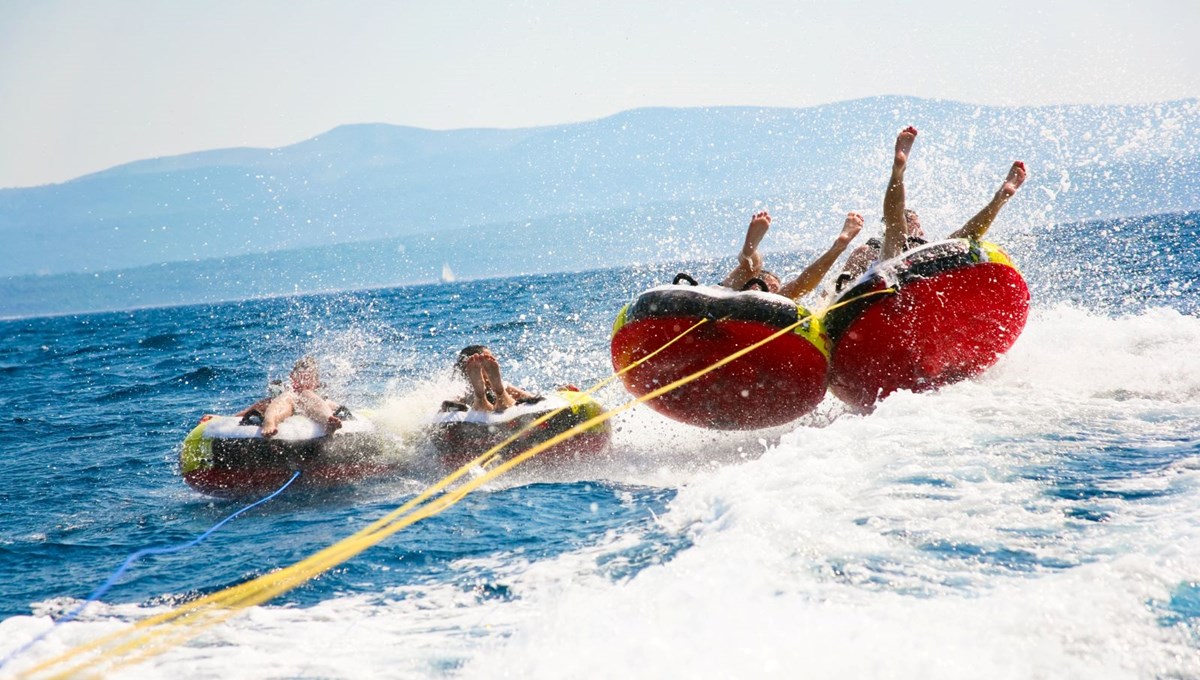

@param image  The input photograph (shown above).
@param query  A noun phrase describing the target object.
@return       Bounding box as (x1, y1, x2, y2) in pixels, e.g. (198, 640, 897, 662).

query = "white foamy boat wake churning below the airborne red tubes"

(0, 307, 1200, 679)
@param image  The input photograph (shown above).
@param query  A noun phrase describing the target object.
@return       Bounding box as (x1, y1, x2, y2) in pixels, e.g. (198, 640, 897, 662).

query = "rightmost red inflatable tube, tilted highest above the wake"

(824, 239, 1030, 410)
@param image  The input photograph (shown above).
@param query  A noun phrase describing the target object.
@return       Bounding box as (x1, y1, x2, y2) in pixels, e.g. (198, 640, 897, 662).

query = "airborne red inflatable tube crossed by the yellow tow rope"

(612, 275, 829, 429)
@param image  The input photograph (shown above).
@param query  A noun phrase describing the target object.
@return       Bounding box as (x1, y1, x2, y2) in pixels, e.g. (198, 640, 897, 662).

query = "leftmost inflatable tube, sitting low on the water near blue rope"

(179, 409, 395, 498)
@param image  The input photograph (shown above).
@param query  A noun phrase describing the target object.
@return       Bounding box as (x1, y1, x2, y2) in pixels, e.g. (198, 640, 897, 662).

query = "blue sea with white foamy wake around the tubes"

(0, 213, 1200, 678)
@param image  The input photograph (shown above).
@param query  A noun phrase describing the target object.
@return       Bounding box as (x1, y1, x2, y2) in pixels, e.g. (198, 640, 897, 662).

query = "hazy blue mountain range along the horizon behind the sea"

(0, 97, 1200, 316)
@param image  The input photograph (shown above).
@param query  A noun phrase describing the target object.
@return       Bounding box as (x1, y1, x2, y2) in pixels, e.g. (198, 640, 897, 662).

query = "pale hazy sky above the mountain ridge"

(0, 0, 1200, 187)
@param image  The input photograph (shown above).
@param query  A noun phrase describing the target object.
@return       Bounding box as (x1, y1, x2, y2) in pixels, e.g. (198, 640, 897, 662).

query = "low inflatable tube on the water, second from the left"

(430, 390, 612, 469)
